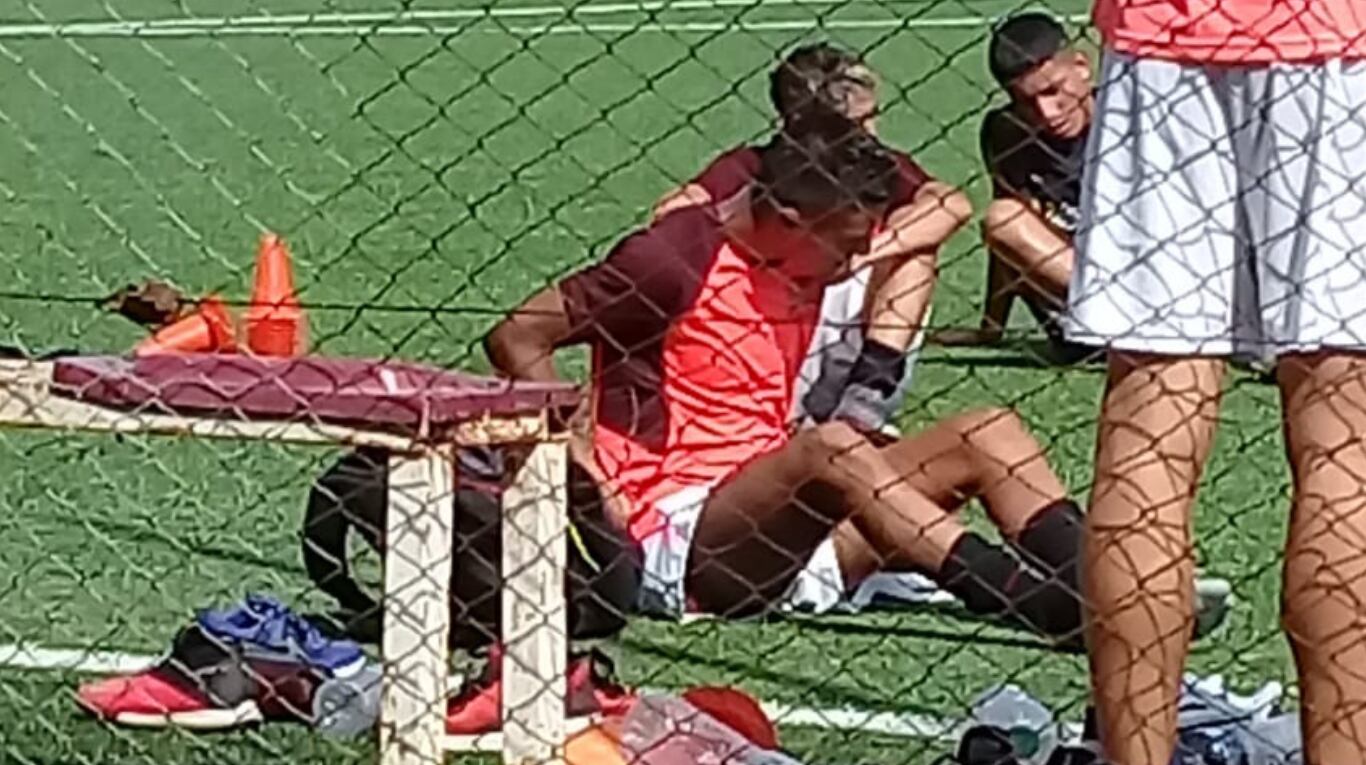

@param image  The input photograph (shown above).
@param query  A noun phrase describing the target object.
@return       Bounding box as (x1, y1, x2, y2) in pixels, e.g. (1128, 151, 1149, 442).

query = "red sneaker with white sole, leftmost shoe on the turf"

(76, 669, 261, 731)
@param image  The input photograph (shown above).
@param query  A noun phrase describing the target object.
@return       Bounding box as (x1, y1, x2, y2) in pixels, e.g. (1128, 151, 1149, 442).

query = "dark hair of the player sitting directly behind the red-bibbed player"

(769, 42, 877, 119)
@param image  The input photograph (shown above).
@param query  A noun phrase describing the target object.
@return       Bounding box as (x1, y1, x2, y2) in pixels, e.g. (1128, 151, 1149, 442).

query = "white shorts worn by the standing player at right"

(1064, 51, 1366, 357)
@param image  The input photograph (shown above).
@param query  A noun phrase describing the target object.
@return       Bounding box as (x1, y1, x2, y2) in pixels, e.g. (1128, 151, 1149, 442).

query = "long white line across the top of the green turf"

(0, 14, 1089, 40)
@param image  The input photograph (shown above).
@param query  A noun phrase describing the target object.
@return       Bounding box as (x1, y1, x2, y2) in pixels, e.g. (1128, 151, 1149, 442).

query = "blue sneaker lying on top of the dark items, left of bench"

(197, 594, 366, 678)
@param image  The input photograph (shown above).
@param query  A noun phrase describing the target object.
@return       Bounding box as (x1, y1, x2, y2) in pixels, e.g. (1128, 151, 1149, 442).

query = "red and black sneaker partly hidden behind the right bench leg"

(445, 646, 635, 735)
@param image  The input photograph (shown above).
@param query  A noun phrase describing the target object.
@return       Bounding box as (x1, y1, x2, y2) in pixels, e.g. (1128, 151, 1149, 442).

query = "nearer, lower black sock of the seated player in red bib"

(932, 531, 1082, 645)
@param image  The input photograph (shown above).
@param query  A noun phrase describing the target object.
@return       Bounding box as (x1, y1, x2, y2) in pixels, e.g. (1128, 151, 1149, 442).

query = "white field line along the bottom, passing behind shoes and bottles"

(0, 645, 1081, 740)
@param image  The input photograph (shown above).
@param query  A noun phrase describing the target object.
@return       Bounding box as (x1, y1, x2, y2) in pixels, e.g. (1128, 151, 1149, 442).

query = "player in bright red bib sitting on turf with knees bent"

(486, 133, 1229, 641)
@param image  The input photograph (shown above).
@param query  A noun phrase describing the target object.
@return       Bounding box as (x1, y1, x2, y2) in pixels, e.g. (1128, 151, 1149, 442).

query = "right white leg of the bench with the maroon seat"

(503, 441, 568, 765)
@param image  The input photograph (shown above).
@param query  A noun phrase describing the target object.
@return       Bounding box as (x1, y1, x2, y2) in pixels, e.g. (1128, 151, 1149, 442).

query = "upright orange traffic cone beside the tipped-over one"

(246, 232, 307, 357)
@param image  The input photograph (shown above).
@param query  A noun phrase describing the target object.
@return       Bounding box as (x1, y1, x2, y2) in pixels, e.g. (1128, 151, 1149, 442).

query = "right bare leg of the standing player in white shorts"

(1279, 355, 1366, 765)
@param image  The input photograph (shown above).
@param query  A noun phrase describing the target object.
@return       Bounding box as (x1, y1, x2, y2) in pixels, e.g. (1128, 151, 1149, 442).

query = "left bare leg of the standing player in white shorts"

(1083, 352, 1223, 765)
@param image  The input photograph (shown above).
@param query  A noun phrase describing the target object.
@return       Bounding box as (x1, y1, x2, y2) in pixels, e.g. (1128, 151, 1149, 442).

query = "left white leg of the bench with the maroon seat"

(380, 449, 455, 765)
